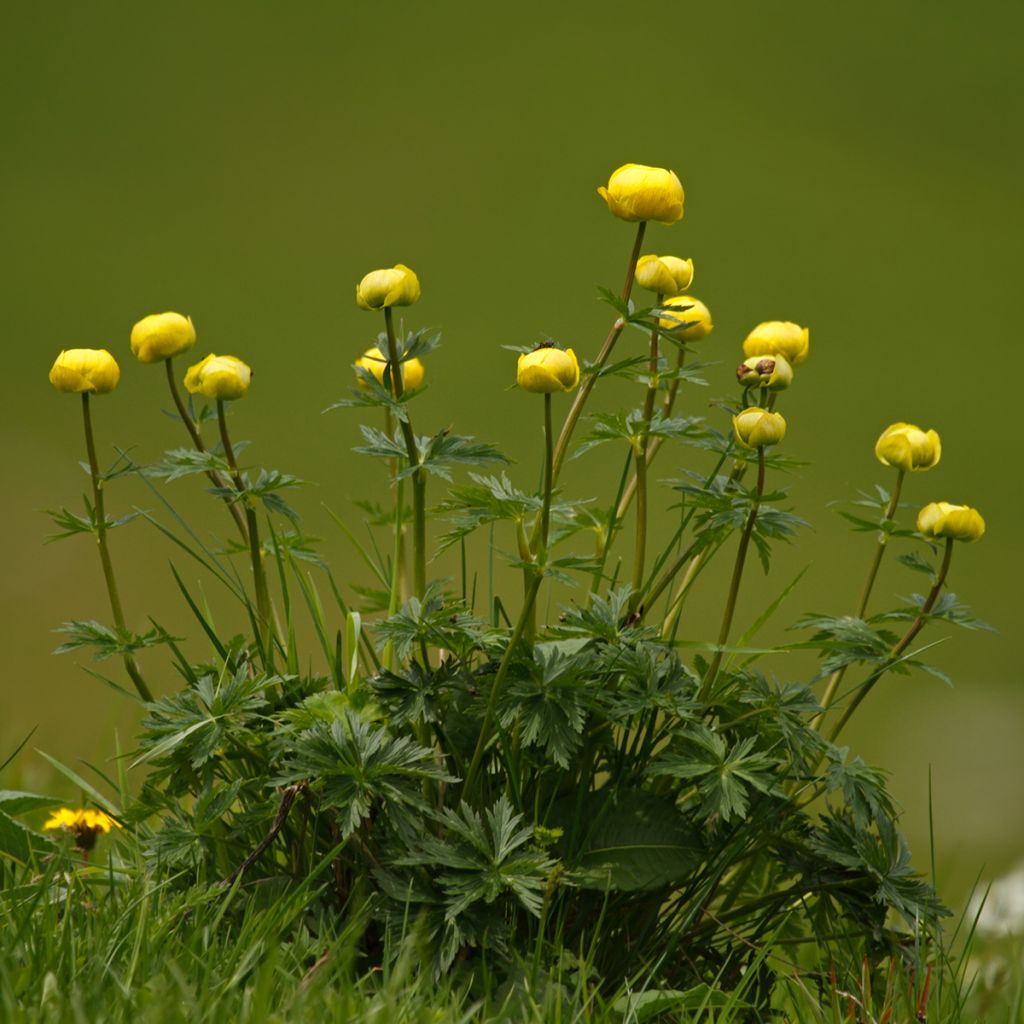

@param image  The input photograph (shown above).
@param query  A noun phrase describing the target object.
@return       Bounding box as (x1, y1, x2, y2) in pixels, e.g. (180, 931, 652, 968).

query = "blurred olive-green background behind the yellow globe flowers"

(0, 0, 1024, 913)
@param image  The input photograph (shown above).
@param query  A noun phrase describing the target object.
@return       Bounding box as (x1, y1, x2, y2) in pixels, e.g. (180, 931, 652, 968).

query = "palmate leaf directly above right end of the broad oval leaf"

(648, 725, 784, 822)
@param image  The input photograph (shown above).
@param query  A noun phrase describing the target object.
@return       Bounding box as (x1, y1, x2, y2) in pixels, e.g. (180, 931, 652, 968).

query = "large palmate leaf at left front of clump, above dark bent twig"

(272, 709, 456, 839)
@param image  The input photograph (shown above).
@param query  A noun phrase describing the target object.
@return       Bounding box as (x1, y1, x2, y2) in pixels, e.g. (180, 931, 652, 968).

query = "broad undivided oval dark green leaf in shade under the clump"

(561, 786, 705, 892)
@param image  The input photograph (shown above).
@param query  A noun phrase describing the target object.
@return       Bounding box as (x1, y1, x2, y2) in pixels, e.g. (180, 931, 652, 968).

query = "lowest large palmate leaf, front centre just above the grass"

(398, 796, 555, 922)
